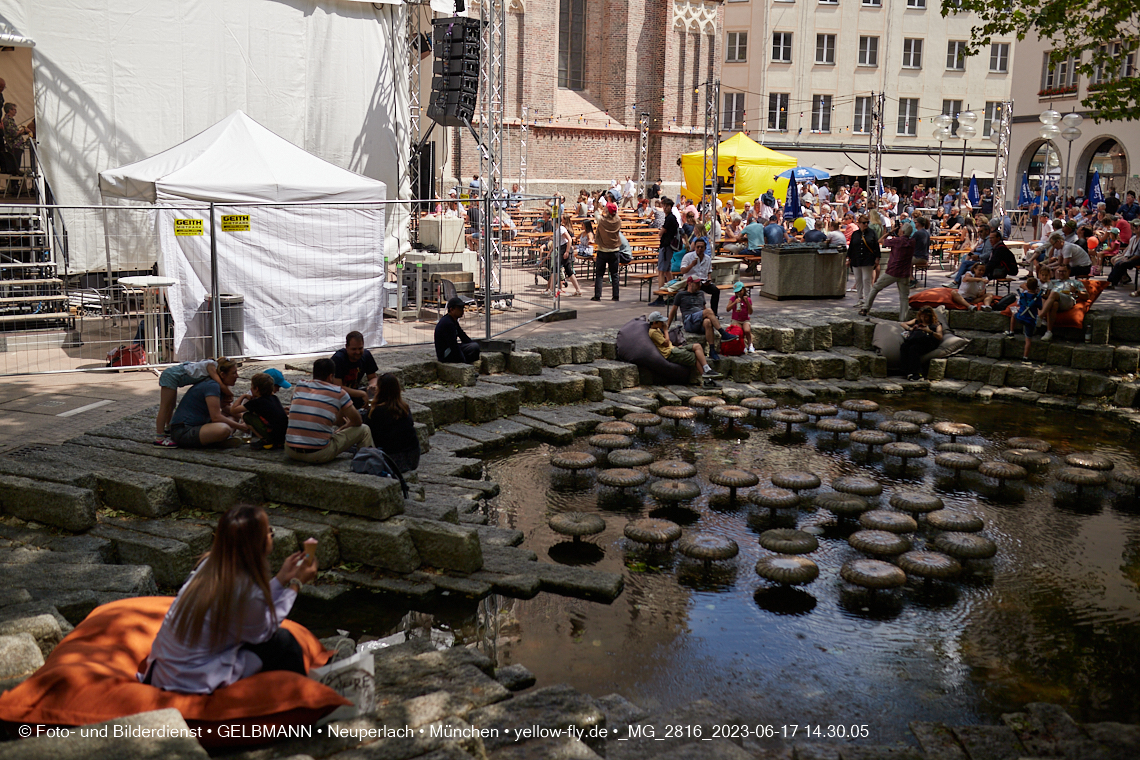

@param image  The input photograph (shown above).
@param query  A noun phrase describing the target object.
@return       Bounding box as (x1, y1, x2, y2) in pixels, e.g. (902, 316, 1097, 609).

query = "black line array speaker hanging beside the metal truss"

(428, 16, 481, 126)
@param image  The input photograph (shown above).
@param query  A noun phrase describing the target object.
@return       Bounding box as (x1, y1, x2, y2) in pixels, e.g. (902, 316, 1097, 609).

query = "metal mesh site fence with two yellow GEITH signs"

(0, 198, 560, 375)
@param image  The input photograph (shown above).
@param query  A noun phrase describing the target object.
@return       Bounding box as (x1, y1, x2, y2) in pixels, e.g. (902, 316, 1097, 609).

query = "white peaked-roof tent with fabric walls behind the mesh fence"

(99, 111, 386, 361)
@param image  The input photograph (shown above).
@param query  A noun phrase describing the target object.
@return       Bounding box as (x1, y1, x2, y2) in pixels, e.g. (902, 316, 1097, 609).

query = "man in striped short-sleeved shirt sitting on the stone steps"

(285, 359, 373, 464)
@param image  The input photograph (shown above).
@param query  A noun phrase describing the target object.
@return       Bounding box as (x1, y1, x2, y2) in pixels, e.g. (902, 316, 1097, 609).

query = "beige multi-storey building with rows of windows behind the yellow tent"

(722, 0, 1015, 186)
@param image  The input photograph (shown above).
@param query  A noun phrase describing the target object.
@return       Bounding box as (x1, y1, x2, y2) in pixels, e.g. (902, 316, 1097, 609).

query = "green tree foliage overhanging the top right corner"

(942, 0, 1140, 122)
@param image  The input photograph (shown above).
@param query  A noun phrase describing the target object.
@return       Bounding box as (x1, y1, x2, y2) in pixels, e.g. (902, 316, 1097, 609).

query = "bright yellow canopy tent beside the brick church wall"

(681, 132, 797, 210)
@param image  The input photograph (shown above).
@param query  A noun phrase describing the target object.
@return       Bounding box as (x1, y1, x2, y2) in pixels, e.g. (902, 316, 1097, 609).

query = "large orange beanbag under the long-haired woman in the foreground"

(0, 596, 350, 747)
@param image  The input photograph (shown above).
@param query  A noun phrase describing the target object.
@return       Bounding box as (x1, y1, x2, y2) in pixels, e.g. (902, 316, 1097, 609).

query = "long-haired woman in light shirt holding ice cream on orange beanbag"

(139, 505, 317, 694)
